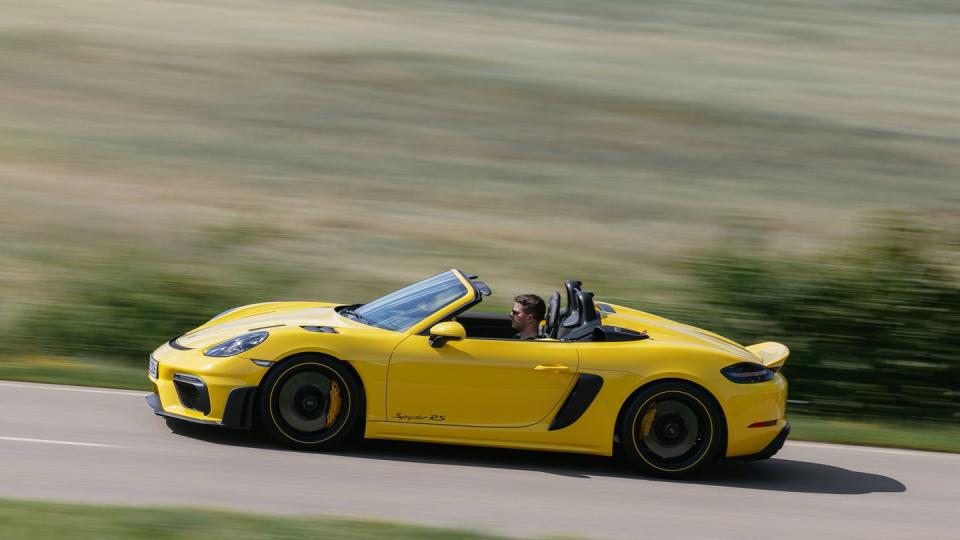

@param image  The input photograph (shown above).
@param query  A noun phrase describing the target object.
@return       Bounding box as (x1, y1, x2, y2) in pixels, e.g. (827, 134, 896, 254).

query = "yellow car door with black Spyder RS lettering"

(387, 335, 578, 427)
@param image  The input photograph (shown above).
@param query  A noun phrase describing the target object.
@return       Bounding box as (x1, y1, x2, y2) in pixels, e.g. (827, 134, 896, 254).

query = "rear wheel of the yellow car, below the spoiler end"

(619, 382, 724, 478)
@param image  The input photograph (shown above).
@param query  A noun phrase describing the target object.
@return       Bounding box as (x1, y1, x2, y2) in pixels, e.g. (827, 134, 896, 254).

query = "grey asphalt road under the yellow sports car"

(0, 381, 960, 540)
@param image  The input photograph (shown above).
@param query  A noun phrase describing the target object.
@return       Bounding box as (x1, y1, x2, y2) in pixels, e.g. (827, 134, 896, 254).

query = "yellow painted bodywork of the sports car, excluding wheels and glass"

(149, 270, 788, 457)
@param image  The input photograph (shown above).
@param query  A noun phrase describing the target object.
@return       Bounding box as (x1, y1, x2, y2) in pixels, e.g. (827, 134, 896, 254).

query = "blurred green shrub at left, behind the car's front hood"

(13, 254, 289, 364)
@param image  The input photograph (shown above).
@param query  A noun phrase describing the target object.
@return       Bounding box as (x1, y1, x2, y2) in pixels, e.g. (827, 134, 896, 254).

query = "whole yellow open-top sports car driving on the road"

(147, 270, 790, 476)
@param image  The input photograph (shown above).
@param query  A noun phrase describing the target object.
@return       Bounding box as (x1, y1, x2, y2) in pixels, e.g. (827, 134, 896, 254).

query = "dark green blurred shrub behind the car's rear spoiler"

(686, 220, 960, 421)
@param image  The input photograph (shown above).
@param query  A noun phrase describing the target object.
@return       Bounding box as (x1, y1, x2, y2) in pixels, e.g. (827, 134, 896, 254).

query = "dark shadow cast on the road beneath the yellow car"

(167, 420, 907, 495)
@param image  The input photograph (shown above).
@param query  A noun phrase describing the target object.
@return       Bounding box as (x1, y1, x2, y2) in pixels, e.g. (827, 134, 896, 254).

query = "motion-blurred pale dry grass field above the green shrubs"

(0, 0, 960, 321)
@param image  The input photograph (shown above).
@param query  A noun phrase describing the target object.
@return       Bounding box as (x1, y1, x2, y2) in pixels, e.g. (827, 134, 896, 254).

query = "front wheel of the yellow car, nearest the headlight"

(257, 356, 364, 450)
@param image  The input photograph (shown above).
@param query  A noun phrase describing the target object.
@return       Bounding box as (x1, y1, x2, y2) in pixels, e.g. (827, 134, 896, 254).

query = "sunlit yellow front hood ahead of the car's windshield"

(176, 302, 371, 349)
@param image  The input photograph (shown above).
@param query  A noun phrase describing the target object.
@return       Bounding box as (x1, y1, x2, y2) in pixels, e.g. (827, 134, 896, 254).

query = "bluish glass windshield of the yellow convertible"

(351, 272, 467, 332)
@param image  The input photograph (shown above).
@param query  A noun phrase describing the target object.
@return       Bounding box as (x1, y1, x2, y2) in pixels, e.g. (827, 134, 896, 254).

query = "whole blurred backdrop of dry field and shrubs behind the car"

(0, 0, 960, 425)
